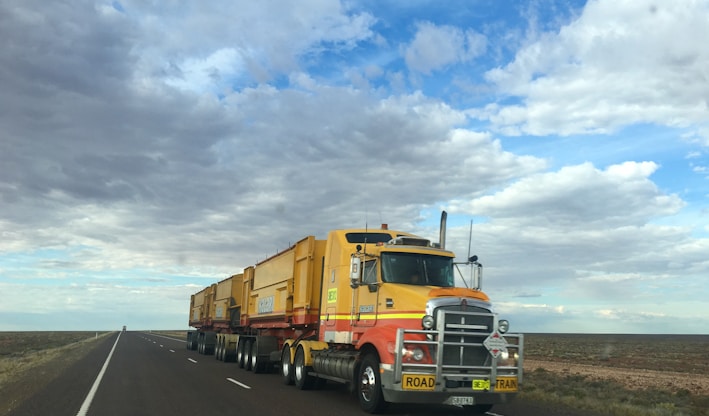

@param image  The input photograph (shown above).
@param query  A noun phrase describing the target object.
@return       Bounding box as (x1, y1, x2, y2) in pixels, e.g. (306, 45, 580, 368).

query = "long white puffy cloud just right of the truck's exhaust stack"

(454, 162, 684, 229)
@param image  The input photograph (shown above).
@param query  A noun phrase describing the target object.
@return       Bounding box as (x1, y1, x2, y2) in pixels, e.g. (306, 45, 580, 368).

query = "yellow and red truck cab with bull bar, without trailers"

(302, 228, 523, 413)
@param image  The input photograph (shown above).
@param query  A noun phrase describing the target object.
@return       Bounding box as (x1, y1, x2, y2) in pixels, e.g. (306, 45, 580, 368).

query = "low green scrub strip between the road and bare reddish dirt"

(520, 368, 709, 416)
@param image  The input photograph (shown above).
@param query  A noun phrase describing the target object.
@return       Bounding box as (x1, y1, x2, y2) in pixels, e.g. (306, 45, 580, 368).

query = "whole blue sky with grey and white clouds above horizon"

(0, 0, 709, 334)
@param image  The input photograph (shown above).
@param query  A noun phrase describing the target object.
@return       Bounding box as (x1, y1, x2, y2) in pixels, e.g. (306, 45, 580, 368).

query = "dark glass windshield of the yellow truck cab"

(382, 252, 455, 287)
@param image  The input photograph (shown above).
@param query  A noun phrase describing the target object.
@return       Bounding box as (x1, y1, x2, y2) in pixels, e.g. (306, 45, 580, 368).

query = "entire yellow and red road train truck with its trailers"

(187, 212, 523, 414)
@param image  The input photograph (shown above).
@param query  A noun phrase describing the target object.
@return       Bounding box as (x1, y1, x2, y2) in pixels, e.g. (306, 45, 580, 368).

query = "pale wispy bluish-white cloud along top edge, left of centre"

(122, 0, 375, 93)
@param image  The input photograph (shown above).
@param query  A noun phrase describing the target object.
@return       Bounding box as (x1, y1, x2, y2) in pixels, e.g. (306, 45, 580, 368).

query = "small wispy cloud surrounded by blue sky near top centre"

(404, 22, 487, 74)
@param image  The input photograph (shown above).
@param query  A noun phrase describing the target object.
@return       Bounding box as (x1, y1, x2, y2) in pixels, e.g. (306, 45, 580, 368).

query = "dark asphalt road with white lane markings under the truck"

(12, 332, 589, 416)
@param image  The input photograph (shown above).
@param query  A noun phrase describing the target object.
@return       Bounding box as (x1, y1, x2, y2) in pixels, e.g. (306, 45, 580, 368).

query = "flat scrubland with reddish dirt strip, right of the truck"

(520, 334, 709, 416)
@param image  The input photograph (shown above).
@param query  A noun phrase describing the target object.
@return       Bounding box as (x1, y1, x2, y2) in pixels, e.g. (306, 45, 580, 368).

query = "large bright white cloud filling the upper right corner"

(481, 1, 709, 140)
